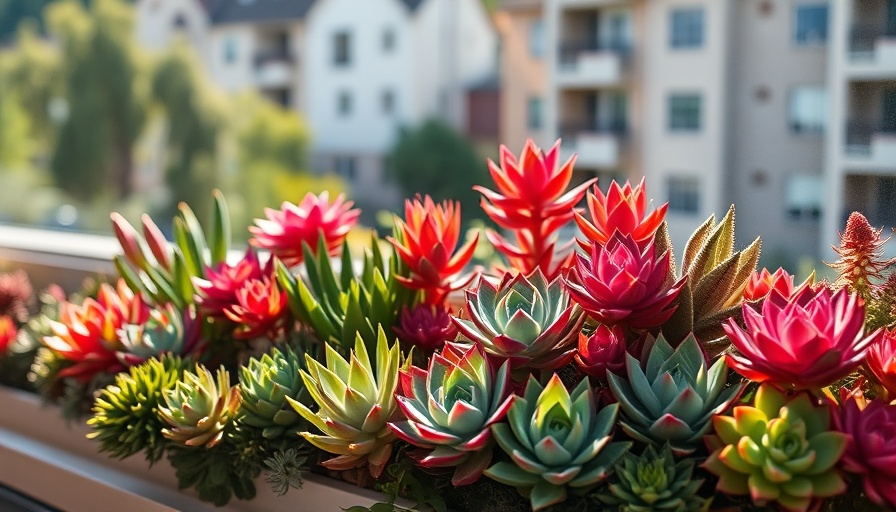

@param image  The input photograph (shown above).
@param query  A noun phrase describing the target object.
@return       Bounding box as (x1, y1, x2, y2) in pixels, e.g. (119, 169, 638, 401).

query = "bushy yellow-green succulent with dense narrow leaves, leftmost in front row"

(87, 356, 184, 464)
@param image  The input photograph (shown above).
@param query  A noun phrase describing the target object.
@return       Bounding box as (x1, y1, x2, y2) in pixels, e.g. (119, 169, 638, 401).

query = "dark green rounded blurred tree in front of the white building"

(388, 119, 488, 220)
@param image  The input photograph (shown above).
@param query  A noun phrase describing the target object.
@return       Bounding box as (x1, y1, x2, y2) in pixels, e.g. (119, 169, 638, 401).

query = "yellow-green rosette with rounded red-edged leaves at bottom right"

(703, 383, 849, 512)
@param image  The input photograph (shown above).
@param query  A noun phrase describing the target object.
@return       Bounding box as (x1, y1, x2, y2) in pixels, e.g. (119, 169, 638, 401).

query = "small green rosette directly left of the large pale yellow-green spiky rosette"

(239, 348, 307, 440)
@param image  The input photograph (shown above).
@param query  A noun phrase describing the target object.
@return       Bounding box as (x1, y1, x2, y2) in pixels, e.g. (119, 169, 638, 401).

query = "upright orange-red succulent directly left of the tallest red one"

(389, 196, 479, 304)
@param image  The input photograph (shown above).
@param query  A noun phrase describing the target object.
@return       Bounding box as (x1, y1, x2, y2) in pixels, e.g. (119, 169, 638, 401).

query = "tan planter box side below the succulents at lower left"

(0, 386, 400, 512)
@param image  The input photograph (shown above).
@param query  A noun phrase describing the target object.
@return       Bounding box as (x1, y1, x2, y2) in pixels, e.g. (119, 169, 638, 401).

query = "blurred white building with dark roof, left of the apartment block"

(137, 0, 497, 212)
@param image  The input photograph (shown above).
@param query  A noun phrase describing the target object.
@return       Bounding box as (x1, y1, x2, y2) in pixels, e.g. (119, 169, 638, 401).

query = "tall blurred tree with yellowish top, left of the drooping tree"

(46, 0, 147, 200)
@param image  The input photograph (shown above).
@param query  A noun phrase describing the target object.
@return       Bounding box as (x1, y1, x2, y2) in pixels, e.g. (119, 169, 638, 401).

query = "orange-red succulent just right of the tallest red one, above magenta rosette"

(575, 178, 669, 252)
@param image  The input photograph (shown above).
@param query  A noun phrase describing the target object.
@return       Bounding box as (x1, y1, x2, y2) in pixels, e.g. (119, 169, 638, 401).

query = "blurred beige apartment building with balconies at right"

(498, 0, 896, 264)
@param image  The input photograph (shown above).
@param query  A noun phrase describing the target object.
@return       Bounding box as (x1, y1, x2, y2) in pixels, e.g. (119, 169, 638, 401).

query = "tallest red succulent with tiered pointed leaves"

(473, 139, 596, 279)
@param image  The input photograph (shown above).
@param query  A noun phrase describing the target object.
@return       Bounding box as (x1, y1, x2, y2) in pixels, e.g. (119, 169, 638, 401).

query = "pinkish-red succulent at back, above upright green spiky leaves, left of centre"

(249, 191, 361, 266)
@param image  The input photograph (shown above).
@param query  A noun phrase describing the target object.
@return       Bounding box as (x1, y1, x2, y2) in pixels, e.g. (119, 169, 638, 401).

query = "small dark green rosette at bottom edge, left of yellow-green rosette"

(599, 445, 707, 512)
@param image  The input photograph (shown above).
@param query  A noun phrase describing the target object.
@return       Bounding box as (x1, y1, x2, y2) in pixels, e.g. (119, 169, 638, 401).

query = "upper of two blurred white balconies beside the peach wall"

(557, 42, 631, 87)
